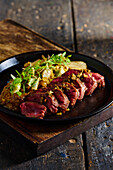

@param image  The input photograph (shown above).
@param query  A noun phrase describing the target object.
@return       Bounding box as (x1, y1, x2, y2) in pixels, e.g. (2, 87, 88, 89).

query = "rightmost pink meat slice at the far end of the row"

(91, 72, 105, 88)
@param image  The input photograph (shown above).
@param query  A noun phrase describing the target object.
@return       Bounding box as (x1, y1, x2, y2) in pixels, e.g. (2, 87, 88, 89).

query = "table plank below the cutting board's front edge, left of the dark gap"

(11, 135, 85, 170)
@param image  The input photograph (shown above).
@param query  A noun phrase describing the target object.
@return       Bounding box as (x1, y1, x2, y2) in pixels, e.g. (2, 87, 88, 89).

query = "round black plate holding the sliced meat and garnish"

(0, 51, 113, 122)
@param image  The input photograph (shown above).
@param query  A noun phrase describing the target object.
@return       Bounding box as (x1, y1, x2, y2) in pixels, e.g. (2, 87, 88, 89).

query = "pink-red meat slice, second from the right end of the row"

(82, 72, 98, 95)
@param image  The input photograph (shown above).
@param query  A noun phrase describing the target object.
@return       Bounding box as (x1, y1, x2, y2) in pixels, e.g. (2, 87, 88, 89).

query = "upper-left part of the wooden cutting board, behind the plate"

(0, 20, 66, 61)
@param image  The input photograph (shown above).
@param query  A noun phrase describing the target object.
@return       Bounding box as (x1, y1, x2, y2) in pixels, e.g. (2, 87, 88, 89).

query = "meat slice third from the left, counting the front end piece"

(53, 89, 70, 113)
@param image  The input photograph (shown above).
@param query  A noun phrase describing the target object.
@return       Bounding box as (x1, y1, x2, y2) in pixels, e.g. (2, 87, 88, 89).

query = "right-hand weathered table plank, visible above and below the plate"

(74, 0, 113, 170)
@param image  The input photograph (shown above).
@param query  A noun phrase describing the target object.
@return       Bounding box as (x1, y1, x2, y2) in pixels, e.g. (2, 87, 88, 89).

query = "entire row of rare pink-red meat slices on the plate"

(20, 69, 105, 119)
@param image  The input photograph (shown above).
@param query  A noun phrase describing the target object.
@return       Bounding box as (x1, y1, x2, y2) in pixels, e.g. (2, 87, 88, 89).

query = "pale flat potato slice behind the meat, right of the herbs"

(68, 61, 87, 70)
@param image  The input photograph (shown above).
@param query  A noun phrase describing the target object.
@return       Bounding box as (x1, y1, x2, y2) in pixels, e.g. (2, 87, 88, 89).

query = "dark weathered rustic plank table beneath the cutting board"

(0, 0, 113, 170)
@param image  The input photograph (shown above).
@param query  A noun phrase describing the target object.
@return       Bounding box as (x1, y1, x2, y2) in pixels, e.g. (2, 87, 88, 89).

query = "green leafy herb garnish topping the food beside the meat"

(10, 52, 71, 96)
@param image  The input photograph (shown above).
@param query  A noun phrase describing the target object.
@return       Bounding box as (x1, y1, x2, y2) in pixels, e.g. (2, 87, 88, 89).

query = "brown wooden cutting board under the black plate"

(0, 20, 113, 155)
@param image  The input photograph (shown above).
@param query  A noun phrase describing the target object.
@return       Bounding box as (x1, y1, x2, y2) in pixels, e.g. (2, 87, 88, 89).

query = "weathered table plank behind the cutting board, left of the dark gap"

(0, 0, 74, 50)
